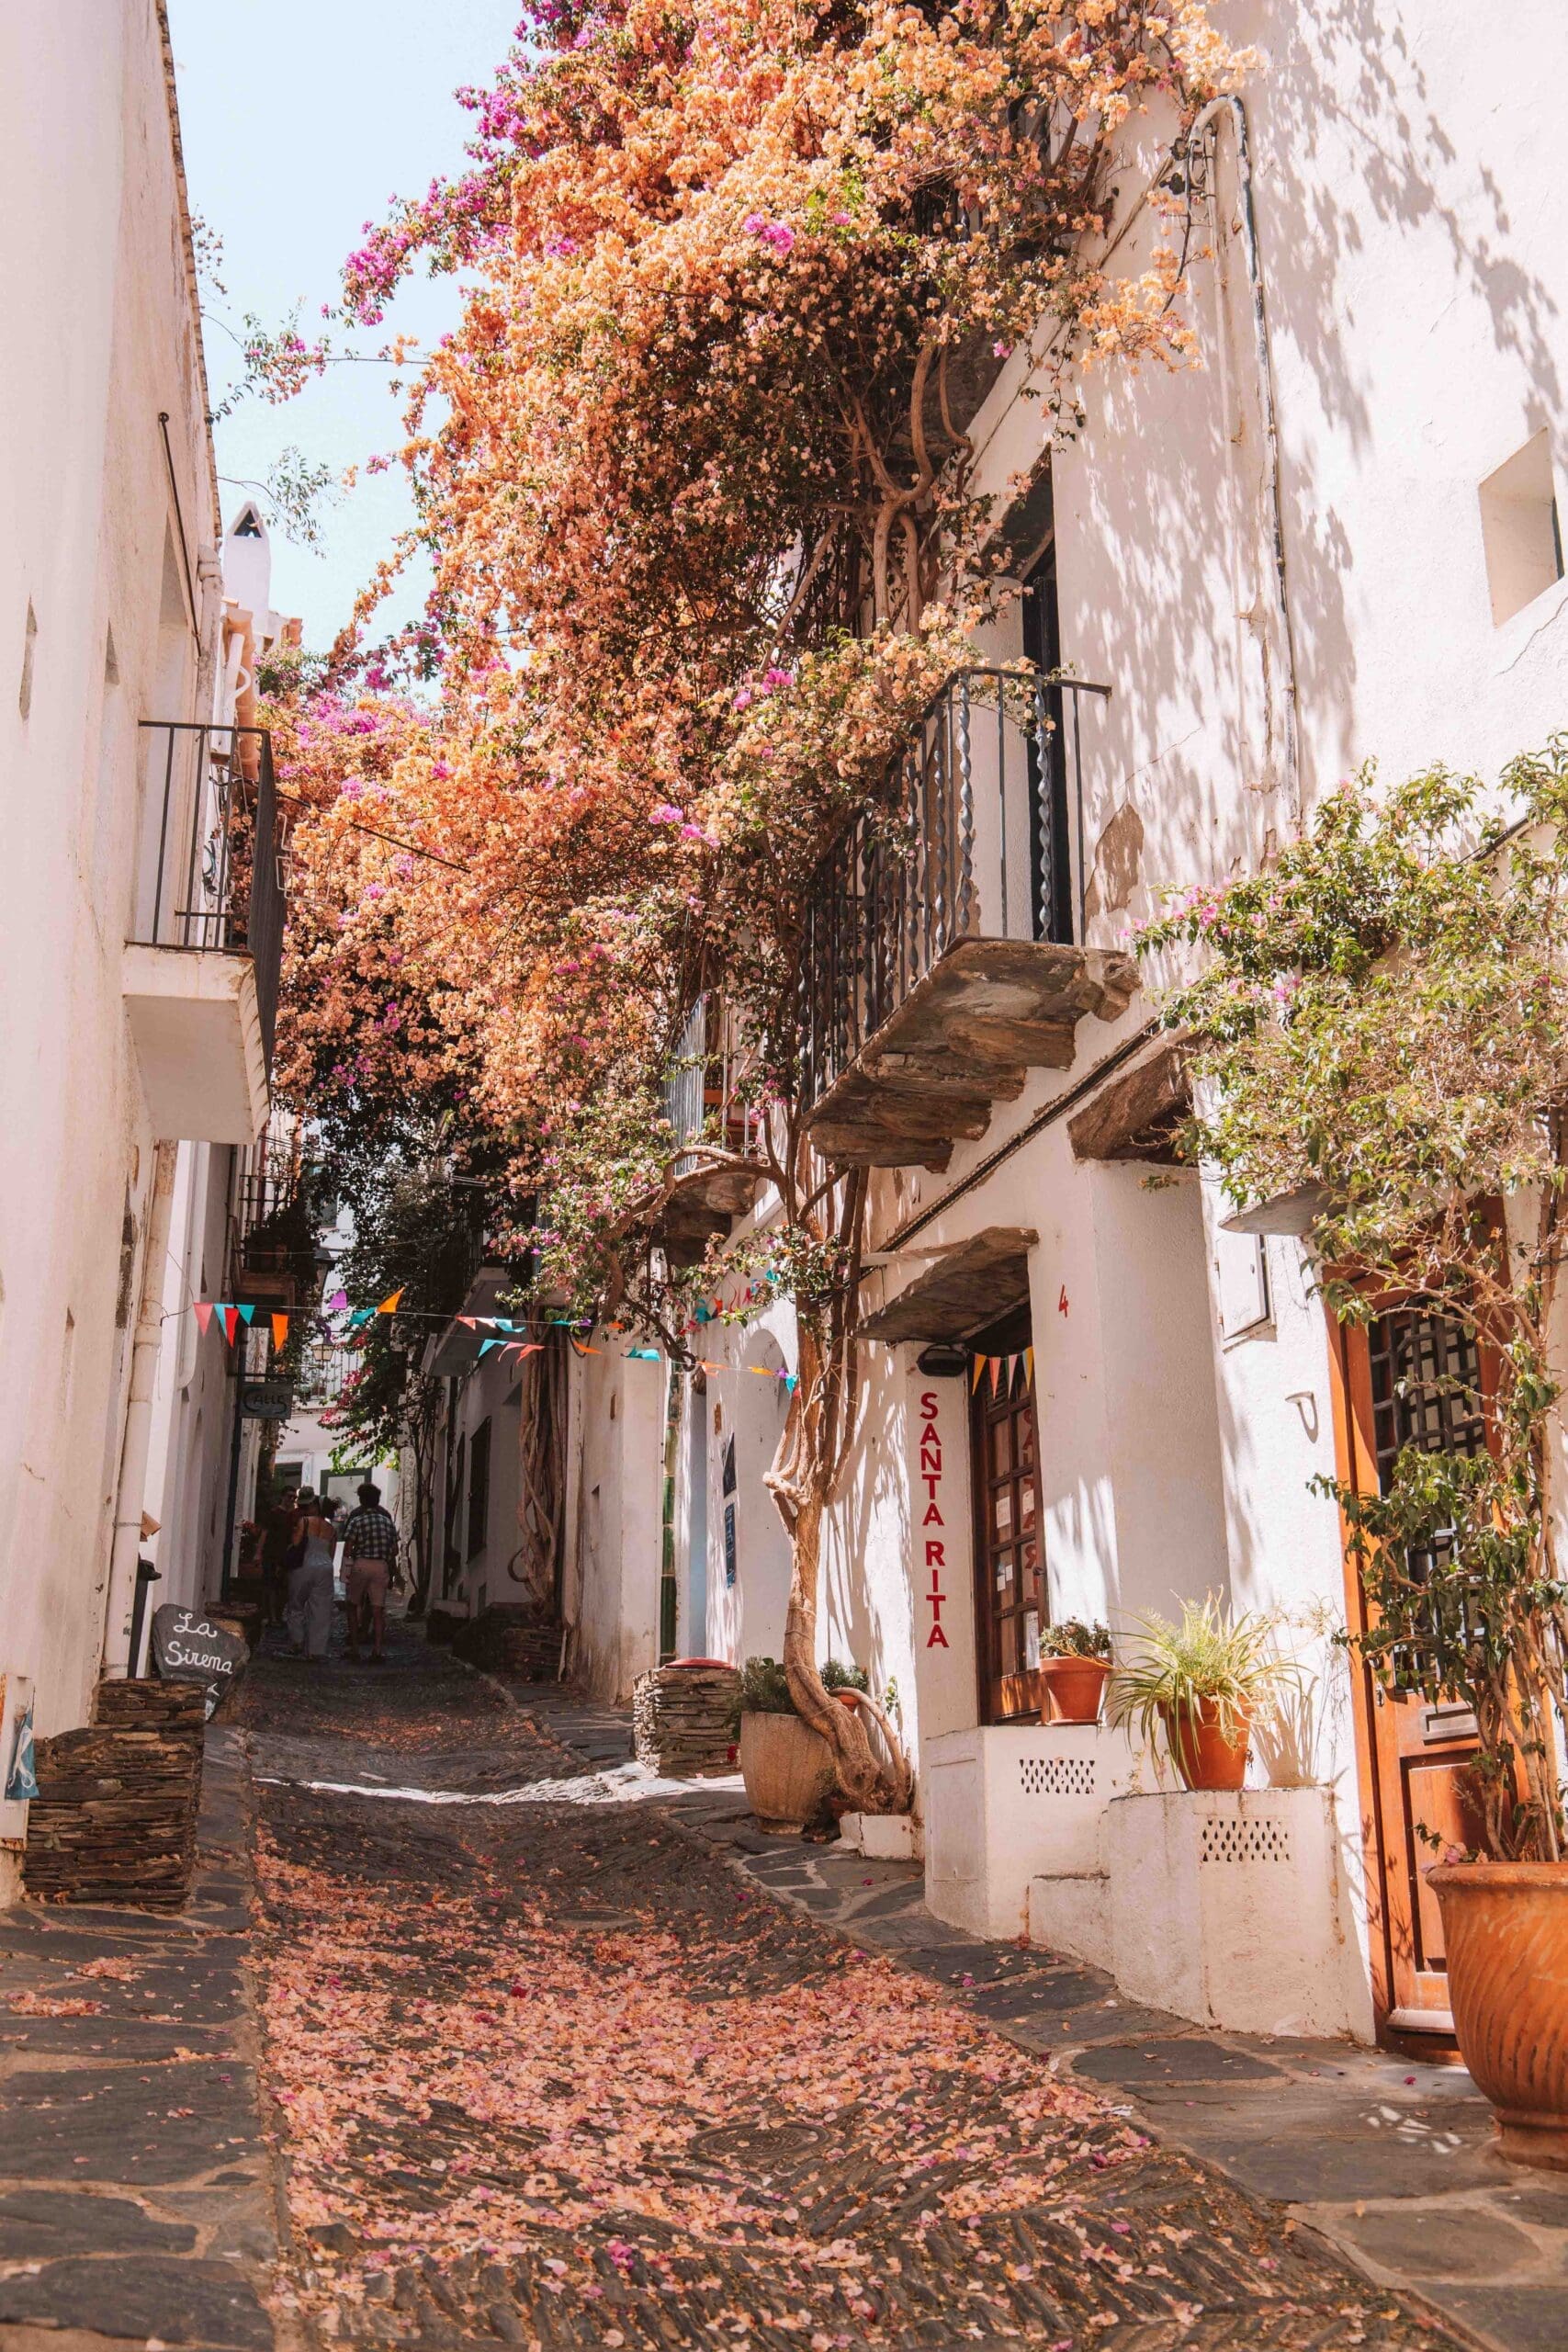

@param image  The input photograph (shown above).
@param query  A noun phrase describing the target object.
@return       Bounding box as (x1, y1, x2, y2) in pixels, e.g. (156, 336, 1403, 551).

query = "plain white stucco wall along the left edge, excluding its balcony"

(0, 0, 216, 1734)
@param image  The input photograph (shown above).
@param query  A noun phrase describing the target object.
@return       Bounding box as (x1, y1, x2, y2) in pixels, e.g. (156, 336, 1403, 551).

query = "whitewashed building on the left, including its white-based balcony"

(0, 0, 282, 1900)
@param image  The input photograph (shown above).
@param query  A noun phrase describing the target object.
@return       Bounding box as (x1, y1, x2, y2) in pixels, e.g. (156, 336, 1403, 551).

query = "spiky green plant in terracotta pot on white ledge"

(1110, 1592, 1295, 1790)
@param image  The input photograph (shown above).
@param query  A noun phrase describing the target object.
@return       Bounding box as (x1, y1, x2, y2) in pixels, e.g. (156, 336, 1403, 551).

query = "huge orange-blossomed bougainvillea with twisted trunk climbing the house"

(278, 0, 1239, 1804)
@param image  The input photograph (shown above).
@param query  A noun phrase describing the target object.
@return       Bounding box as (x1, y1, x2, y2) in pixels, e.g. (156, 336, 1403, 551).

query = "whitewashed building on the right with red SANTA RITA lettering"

(549, 0, 1568, 2049)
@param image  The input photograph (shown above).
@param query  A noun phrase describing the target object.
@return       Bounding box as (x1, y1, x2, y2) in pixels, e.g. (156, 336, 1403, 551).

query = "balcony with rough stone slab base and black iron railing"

(799, 668, 1138, 1169)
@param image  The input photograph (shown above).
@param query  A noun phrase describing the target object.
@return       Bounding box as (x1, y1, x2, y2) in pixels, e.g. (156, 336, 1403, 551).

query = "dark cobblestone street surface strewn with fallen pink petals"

(230, 1637, 1455, 2352)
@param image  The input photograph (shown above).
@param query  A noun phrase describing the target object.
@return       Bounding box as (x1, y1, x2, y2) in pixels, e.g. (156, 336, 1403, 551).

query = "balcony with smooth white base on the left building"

(122, 719, 282, 1143)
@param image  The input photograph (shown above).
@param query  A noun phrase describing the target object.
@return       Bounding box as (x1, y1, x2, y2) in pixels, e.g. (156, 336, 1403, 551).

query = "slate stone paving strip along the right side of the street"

(658, 1788, 1568, 2352)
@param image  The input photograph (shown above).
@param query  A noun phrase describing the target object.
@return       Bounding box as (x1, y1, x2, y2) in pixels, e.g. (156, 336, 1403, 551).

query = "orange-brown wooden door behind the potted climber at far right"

(1336, 1306, 1493, 2041)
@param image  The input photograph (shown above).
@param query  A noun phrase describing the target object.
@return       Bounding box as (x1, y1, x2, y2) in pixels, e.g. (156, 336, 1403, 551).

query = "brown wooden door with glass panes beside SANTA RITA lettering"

(971, 1317, 1048, 1724)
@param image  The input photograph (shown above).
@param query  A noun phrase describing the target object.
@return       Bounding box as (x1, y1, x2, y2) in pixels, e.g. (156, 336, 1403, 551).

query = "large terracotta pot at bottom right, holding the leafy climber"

(1427, 1863, 1568, 2173)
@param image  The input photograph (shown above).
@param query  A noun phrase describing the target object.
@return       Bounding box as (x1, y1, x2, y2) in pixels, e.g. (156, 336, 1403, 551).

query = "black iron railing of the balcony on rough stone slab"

(799, 668, 1110, 1103)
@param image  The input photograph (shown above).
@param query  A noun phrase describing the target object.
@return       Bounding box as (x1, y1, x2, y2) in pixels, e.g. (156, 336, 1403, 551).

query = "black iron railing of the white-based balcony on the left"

(131, 719, 285, 1068)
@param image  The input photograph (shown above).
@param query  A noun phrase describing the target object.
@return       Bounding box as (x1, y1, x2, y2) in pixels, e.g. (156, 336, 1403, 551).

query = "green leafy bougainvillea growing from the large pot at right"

(1140, 739, 1568, 1860)
